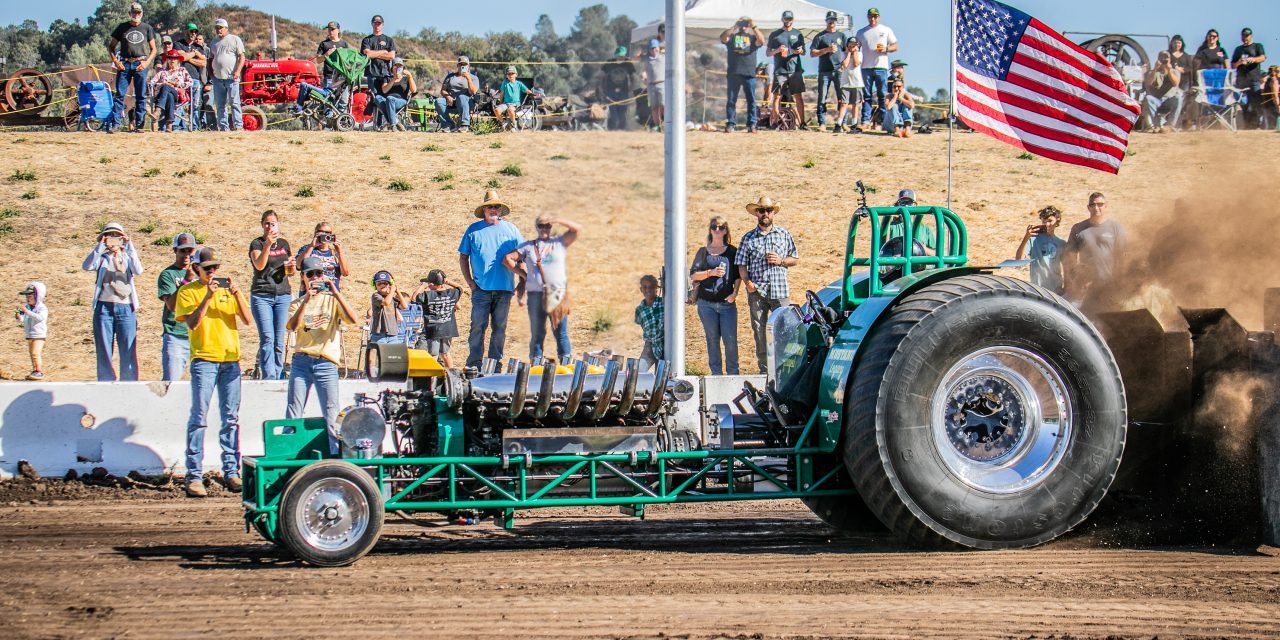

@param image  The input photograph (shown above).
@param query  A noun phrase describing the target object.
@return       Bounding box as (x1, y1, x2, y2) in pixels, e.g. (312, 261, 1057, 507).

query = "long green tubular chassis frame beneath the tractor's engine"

(242, 413, 855, 540)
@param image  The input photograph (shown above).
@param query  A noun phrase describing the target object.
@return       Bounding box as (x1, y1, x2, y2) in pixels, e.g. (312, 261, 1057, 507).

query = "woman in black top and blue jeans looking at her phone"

(248, 209, 294, 380)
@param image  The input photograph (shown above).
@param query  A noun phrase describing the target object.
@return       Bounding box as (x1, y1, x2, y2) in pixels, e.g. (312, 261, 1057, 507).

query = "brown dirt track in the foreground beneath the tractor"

(0, 497, 1280, 637)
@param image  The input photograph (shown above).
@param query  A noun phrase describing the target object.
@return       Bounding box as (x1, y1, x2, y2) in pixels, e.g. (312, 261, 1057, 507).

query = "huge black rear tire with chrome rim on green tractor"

(844, 275, 1126, 549)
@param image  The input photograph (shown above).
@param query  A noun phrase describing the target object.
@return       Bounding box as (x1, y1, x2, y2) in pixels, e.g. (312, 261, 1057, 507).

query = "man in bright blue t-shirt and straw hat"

(458, 189, 525, 369)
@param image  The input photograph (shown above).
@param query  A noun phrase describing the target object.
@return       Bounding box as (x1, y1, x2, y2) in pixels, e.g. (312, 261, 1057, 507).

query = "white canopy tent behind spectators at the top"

(631, 0, 854, 46)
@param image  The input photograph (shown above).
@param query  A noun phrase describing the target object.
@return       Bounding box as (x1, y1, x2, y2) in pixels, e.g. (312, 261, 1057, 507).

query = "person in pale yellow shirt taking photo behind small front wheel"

(284, 257, 356, 453)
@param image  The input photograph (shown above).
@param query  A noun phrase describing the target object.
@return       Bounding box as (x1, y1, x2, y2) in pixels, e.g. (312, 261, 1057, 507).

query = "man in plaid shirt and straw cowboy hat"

(733, 196, 800, 374)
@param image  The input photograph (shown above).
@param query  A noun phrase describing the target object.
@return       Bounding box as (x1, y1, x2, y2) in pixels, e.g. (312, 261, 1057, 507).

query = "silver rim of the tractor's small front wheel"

(294, 477, 369, 552)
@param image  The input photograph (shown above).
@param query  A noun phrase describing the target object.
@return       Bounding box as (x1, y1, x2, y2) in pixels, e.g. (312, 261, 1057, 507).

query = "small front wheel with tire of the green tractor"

(279, 460, 384, 567)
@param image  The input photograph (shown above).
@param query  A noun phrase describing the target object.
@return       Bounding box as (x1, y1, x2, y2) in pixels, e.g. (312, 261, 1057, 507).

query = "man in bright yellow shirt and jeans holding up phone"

(173, 247, 252, 498)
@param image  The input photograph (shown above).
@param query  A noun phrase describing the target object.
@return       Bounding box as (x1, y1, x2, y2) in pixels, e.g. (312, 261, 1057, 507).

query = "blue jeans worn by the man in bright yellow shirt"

(187, 358, 239, 483)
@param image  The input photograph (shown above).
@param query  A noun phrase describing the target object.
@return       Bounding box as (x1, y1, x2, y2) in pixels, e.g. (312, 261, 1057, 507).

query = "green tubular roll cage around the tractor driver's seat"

(840, 206, 969, 311)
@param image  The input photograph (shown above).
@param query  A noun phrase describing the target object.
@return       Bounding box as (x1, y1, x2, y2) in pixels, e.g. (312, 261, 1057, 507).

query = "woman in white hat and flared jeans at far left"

(81, 223, 142, 381)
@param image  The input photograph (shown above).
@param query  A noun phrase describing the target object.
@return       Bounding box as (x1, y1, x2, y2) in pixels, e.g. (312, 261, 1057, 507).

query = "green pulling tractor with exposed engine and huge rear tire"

(242, 189, 1128, 566)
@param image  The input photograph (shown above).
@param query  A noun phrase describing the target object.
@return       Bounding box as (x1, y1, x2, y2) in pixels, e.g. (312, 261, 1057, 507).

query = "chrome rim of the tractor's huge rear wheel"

(931, 346, 1074, 494)
